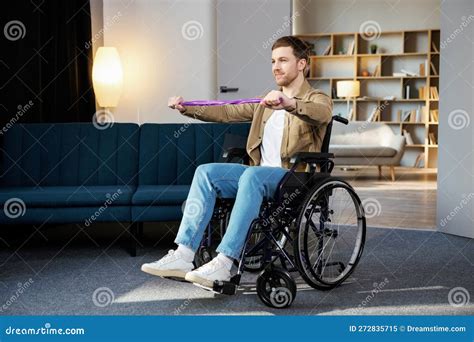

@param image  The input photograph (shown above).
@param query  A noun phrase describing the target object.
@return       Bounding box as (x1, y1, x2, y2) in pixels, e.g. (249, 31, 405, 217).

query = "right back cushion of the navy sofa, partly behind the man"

(139, 123, 250, 185)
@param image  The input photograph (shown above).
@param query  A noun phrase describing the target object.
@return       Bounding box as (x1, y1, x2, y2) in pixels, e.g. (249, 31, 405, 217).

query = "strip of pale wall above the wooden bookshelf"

(293, 0, 440, 34)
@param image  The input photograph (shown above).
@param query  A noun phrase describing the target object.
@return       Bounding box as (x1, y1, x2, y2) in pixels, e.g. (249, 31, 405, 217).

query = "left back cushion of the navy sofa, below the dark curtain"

(0, 123, 139, 186)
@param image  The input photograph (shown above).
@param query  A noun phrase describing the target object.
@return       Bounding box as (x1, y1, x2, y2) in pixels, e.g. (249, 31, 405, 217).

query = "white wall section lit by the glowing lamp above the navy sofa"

(103, 0, 216, 123)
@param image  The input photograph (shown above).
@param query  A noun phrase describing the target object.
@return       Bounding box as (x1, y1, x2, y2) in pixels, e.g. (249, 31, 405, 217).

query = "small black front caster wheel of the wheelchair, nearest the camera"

(257, 268, 296, 309)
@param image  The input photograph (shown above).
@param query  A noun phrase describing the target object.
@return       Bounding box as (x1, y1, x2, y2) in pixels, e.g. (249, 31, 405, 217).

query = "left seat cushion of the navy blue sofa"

(0, 185, 136, 210)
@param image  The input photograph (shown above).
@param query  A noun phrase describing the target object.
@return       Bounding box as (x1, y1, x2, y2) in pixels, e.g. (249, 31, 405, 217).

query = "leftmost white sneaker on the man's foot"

(142, 250, 194, 279)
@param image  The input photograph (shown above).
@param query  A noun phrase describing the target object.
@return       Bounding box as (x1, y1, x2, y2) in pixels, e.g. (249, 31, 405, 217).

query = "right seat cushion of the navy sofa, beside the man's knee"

(132, 185, 190, 205)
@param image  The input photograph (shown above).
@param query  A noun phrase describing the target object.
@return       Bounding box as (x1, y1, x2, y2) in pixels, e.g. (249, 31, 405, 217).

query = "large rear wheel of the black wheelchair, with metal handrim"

(294, 177, 366, 290)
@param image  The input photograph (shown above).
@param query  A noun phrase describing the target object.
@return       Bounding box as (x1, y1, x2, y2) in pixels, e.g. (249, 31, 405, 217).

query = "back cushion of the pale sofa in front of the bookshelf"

(331, 121, 394, 146)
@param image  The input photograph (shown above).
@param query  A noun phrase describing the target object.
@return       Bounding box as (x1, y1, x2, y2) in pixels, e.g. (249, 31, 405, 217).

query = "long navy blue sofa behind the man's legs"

(0, 123, 250, 255)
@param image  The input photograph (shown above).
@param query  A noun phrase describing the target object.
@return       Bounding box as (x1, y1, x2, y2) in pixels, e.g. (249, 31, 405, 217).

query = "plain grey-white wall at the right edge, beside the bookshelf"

(437, 0, 474, 238)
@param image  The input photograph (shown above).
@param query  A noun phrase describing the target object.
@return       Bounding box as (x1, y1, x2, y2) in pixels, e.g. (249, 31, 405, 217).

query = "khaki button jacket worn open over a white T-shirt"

(183, 80, 332, 169)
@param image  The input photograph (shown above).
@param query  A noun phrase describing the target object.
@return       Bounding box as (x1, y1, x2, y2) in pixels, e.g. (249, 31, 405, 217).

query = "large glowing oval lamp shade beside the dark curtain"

(92, 47, 123, 107)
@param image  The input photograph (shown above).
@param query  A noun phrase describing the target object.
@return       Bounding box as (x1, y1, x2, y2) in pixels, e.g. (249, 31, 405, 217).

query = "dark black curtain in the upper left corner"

(0, 0, 95, 127)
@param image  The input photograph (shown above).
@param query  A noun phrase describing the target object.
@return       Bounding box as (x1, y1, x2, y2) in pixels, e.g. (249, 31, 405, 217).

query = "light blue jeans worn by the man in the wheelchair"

(175, 163, 288, 259)
